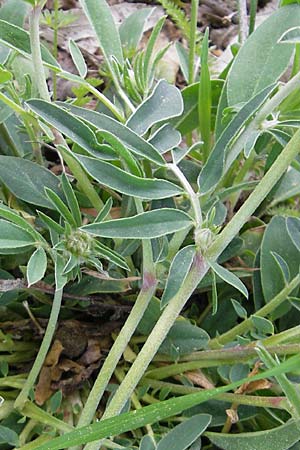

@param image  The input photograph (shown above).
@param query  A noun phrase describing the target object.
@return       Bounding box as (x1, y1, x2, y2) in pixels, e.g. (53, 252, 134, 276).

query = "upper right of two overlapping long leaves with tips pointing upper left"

(55, 103, 165, 166)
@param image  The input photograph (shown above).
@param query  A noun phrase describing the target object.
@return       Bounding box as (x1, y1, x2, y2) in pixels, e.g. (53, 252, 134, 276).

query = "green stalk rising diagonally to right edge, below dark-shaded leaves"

(209, 272, 300, 348)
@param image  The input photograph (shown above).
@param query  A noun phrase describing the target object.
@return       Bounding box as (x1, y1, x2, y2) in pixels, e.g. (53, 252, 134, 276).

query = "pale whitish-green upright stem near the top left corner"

(30, 4, 50, 101)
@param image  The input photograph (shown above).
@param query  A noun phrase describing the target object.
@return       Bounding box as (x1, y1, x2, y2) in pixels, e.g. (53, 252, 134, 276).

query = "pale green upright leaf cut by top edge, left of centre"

(80, 0, 124, 73)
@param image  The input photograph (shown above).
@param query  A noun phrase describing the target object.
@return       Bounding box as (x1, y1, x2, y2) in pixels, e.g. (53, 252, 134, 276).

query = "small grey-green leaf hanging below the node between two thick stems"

(160, 245, 196, 309)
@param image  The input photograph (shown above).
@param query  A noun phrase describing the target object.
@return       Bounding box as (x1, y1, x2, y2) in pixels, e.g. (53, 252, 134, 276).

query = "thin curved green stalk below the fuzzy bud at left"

(15, 289, 63, 410)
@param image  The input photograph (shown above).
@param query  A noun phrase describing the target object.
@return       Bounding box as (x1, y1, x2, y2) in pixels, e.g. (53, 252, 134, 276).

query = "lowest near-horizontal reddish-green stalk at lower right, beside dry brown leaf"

(140, 378, 289, 411)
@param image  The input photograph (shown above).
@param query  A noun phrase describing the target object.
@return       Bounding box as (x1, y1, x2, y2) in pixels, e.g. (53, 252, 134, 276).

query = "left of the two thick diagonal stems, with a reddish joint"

(78, 199, 157, 436)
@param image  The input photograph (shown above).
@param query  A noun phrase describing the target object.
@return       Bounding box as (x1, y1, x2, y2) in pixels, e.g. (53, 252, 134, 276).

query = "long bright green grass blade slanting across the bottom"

(31, 355, 300, 450)
